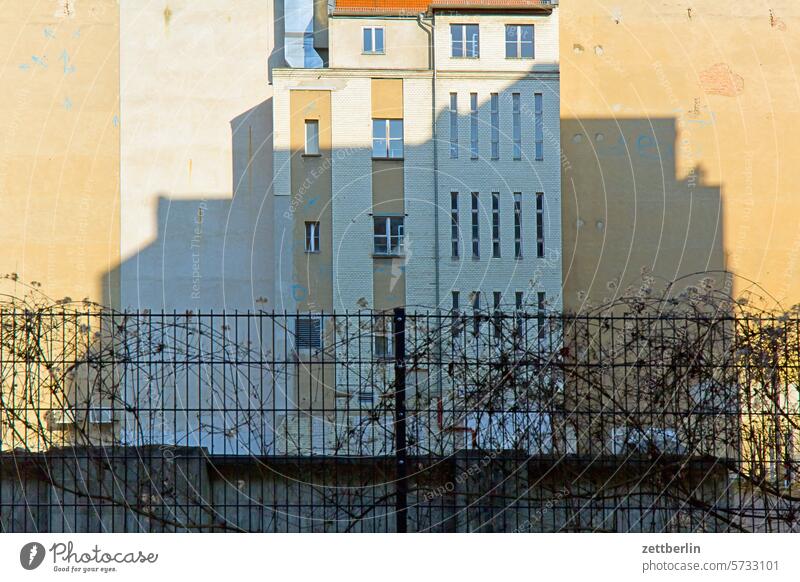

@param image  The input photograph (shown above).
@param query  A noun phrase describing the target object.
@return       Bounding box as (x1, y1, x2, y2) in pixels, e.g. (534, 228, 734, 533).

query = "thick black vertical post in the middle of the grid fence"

(394, 307, 408, 533)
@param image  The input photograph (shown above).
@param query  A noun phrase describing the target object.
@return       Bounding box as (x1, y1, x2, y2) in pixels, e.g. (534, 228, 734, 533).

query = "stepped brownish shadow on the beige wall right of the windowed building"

(561, 117, 732, 312)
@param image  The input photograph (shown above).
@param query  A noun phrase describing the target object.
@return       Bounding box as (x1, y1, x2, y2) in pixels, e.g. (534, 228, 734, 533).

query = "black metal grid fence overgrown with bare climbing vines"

(0, 309, 800, 532)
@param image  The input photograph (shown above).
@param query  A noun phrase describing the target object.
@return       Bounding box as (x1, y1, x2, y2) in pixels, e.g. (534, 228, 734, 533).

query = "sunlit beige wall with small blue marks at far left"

(0, 0, 119, 300)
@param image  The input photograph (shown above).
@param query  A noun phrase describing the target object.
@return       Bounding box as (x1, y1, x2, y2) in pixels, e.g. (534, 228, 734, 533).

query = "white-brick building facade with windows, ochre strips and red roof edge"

(272, 0, 561, 320)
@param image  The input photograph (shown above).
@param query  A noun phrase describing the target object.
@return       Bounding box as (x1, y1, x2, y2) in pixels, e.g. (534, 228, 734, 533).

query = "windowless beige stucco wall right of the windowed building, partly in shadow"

(560, 0, 800, 309)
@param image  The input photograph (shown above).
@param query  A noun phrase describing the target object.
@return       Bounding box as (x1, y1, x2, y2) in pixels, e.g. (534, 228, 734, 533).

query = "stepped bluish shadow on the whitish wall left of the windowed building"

(103, 98, 273, 312)
